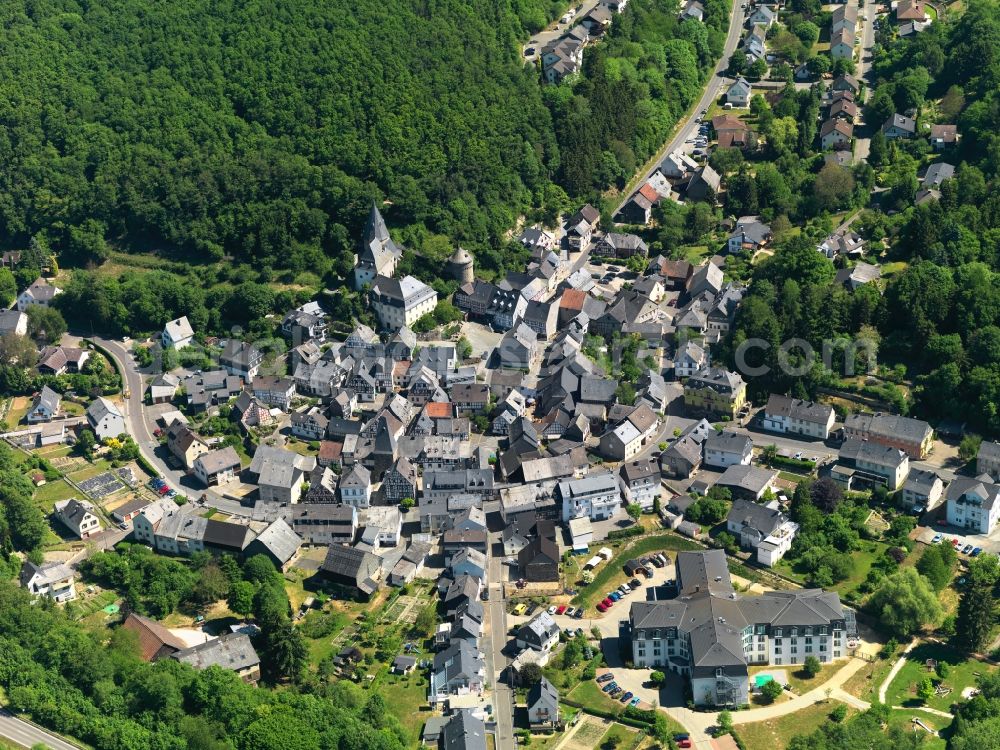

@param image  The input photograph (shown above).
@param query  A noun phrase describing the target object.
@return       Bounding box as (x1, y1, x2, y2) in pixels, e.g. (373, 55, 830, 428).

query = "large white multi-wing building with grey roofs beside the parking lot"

(628, 550, 856, 708)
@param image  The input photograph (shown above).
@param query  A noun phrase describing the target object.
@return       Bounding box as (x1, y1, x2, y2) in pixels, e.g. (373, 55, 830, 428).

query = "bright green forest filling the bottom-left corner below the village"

(0, 580, 405, 750)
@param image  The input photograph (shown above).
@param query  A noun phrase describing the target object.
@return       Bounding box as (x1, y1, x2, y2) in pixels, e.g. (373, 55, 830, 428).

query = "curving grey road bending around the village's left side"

(91, 336, 249, 516)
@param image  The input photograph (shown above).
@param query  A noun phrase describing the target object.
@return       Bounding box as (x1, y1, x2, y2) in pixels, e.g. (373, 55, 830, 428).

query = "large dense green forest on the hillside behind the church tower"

(0, 0, 558, 275)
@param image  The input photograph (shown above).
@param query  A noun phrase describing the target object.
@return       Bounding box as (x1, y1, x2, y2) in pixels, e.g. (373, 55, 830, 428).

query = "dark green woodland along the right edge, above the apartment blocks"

(728, 0, 1000, 433)
